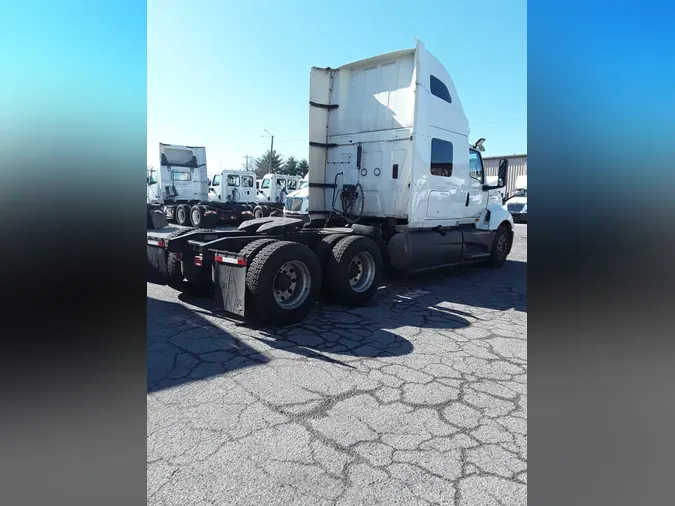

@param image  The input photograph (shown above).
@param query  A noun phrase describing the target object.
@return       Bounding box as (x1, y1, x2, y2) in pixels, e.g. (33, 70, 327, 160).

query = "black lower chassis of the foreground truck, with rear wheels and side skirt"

(147, 211, 513, 325)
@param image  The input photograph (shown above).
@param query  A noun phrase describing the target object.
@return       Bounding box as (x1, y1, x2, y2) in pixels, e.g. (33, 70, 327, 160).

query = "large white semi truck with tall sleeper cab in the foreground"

(147, 42, 513, 325)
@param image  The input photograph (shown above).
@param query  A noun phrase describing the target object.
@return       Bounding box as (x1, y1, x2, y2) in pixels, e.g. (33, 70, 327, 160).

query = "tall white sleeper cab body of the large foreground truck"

(309, 41, 508, 228)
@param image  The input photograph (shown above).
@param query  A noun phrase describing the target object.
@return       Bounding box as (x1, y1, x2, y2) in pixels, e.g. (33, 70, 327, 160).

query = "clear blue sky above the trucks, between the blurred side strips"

(147, 0, 527, 173)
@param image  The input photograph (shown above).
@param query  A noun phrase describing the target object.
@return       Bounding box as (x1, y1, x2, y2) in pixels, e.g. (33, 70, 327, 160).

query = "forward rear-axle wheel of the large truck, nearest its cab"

(325, 235, 383, 306)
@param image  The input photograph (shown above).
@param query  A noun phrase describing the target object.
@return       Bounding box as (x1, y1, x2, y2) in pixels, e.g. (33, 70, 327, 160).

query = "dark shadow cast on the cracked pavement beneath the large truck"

(148, 260, 527, 392)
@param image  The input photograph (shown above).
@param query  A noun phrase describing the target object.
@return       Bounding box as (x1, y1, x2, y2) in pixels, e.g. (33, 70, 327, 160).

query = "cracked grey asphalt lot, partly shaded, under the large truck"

(147, 225, 527, 506)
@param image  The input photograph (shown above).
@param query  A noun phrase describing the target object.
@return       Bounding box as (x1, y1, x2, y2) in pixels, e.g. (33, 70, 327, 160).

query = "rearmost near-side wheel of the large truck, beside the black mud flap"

(246, 241, 321, 325)
